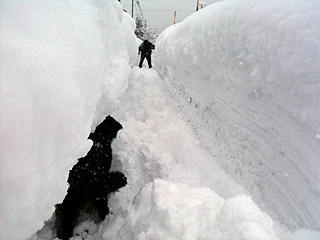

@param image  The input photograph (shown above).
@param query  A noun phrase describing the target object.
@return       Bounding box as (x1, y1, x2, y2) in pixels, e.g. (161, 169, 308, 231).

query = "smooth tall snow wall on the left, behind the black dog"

(0, 0, 137, 240)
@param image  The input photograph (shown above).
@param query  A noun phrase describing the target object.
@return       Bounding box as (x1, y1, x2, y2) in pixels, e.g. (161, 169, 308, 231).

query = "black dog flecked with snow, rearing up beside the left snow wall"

(55, 116, 127, 240)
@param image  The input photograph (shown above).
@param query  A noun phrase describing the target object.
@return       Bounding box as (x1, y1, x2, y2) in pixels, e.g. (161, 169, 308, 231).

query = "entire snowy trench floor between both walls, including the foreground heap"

(95, 67, 276, 239)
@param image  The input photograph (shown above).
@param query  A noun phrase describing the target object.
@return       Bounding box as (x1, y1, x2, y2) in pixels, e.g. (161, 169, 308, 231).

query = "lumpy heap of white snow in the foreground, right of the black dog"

(129, 179, 276, 240)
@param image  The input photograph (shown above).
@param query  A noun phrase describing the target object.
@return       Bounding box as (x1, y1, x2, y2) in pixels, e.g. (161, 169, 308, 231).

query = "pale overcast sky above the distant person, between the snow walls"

(121, 0, 218, 30)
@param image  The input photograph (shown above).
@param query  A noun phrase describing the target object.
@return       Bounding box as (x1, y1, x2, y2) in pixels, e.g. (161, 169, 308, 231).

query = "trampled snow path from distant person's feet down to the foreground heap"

(113, 67, 247, 198)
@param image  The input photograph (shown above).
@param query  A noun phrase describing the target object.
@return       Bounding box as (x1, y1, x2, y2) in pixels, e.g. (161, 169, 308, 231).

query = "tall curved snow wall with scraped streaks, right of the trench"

(154, 1, 320, 230)
